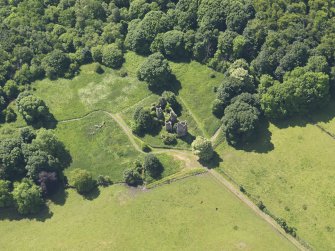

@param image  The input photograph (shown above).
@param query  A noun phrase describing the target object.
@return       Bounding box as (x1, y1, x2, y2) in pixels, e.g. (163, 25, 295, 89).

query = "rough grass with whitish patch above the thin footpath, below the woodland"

(33, 64, 150, 120)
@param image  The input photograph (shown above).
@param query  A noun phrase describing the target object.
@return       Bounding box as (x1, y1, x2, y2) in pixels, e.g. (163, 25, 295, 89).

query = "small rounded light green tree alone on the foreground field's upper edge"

(68, 168, 96, 194)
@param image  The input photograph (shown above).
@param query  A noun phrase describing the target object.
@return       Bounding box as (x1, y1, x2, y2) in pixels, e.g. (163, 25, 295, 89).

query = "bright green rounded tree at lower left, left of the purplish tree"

(13, 179, 43, 215)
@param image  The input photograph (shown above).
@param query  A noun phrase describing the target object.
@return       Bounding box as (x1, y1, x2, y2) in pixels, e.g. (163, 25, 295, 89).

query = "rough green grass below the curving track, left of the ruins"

(55, 112, 181, 181)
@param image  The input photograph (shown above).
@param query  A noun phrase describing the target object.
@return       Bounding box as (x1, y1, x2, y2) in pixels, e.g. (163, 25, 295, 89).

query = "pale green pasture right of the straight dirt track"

(217, 123, 335, 250)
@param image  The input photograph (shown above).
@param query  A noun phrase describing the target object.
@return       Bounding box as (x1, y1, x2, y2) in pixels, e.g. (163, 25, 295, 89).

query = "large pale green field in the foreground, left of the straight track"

(0, 175, 295, 250)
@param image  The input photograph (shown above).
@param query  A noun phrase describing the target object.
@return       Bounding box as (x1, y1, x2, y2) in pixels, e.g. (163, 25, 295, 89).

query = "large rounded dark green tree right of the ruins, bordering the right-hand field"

(222, 98, 260, 146)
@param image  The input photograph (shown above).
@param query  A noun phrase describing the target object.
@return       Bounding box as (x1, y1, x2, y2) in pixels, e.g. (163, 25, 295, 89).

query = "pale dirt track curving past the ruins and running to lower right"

(59, 110, 307, 250)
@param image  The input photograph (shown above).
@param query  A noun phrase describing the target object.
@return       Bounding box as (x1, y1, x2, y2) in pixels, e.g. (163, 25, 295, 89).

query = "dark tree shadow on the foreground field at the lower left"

(0, 206, 53, 222)
